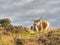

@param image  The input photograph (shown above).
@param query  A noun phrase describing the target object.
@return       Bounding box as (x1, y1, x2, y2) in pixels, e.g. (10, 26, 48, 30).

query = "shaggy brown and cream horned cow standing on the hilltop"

(33, 20, 49, 32)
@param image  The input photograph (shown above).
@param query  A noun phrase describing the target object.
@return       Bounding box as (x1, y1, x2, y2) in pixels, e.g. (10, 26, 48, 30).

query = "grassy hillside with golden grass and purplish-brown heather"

(0, 26, 60, 45)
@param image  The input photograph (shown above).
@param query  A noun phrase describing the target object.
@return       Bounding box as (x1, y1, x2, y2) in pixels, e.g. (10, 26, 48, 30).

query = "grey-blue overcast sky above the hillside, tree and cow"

(0, 0, 60, 27)
